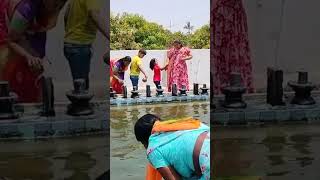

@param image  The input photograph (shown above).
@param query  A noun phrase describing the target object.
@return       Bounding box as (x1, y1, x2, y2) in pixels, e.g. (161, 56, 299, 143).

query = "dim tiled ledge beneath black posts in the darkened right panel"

(211, 94, 320, 126)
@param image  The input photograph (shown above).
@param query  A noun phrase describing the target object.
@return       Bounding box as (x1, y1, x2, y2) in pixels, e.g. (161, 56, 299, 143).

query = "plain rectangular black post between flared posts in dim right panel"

(267, 68, 285, 106)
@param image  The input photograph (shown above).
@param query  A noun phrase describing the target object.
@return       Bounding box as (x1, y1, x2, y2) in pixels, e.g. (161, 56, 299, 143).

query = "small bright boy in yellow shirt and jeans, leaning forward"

(130, 49, 148, 90)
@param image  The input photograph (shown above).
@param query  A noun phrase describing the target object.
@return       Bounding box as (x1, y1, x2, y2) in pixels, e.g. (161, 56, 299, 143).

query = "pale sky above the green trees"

(110, 0, 210, 32)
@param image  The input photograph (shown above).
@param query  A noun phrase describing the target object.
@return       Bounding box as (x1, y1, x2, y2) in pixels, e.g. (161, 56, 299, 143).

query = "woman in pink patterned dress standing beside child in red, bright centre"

(167, 40, 192, 92)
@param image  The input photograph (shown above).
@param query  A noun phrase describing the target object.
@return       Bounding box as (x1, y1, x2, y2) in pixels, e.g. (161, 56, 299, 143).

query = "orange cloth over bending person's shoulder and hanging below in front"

(146, 117, 200, 180)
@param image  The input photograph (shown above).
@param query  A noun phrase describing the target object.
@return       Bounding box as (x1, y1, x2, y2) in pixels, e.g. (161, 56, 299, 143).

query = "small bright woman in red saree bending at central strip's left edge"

(110, 56, 131, 94)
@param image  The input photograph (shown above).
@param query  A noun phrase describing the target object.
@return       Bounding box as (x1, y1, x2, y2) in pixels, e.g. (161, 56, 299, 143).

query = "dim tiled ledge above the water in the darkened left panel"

(0, 103, 109, 139)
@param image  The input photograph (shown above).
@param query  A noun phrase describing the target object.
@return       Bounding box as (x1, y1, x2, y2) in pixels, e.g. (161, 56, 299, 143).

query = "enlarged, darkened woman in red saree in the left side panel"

(2, 0, 66, 103)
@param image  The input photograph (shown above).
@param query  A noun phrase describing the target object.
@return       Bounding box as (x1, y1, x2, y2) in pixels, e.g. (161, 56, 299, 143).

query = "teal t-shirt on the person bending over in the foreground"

(147, 123, 210, 178)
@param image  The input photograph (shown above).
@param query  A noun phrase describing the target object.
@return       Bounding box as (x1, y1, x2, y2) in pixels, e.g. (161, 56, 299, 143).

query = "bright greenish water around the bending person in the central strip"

(110, 102, 210, 180)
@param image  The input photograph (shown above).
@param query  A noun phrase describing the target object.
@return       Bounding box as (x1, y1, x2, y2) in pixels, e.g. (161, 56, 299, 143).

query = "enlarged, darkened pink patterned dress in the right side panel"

(211, 0, 254, 94)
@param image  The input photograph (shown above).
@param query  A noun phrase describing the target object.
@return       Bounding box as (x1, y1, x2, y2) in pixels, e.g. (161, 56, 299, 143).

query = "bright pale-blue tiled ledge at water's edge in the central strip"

(110, 94, 209, 106)
